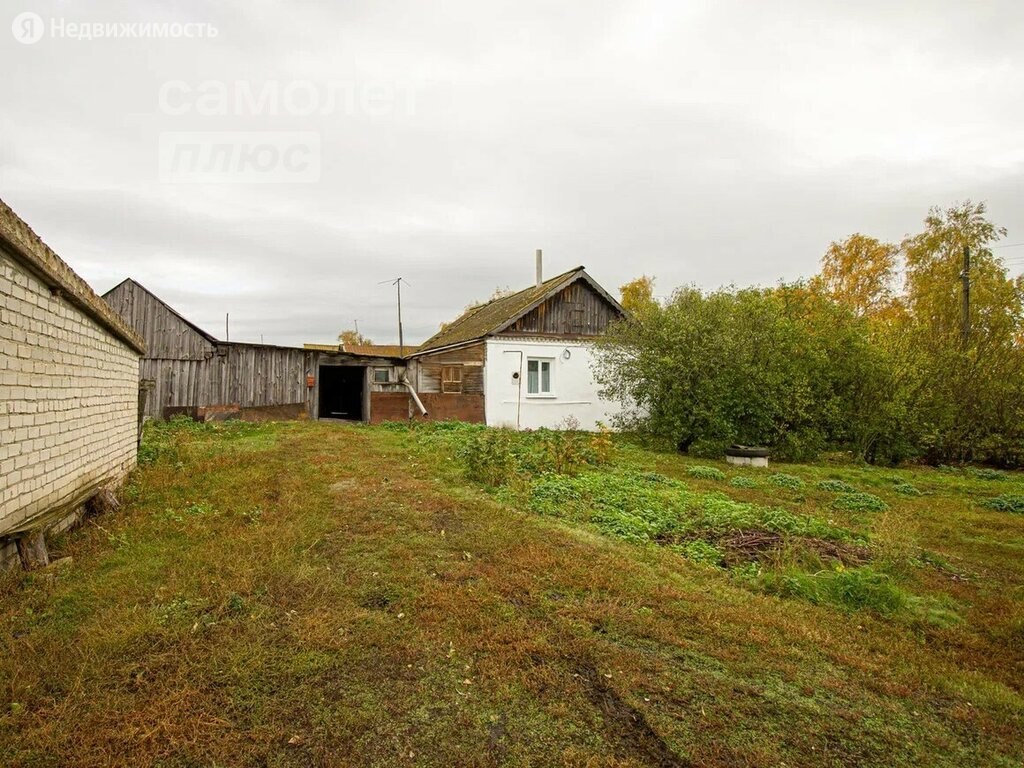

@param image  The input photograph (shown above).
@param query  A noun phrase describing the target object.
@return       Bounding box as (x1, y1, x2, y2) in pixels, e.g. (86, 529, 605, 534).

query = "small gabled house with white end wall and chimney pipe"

(408, 257, 625, 429)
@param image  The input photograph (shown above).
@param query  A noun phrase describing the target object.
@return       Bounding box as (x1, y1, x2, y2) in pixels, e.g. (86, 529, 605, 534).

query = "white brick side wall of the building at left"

(0, 252, 138, 537)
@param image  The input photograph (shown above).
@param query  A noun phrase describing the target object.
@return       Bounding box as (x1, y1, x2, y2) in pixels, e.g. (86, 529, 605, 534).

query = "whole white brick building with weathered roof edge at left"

(0, 202, 144, 566)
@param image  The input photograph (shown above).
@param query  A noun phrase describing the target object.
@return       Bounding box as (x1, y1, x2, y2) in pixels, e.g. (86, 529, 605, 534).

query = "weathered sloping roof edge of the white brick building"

(0, 200, 145, 354)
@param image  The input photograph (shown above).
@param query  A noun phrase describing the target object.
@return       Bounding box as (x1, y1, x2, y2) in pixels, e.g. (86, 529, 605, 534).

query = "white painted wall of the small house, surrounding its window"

(483, 339, 622, 430)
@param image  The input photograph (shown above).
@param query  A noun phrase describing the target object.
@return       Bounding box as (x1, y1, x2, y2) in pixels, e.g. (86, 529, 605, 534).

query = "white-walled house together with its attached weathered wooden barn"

(103, 257, 623, 429)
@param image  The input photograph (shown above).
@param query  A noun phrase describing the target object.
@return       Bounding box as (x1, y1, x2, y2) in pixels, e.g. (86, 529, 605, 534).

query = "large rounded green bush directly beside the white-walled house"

(595, 284, 878, 459)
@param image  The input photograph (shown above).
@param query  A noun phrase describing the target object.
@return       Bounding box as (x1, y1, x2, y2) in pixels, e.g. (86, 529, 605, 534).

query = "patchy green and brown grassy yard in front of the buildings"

(0, 423, 1024, 767)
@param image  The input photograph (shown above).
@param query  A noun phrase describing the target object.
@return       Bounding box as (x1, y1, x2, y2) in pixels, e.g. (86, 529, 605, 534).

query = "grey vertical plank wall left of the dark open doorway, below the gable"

(141, 344, 314, 419)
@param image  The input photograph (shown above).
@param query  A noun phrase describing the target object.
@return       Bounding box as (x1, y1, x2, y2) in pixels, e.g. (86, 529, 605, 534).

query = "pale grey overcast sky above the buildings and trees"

(0, 0, 1024, 344)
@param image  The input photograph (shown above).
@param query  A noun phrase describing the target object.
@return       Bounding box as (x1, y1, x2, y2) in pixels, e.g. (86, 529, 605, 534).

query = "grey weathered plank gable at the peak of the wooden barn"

(103, 280, 213, 360)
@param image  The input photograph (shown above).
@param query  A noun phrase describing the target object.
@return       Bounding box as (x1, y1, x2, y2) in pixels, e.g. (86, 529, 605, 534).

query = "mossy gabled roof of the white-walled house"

(411, 266, 624, 356)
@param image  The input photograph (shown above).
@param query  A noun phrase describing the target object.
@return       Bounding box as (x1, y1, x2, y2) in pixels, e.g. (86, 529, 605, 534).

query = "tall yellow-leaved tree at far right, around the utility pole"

(902, 201, 1024, 463)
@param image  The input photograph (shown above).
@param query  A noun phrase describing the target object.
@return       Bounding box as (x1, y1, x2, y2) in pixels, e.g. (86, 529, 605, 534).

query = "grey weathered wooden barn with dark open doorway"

(103, 279, 410, 422)
